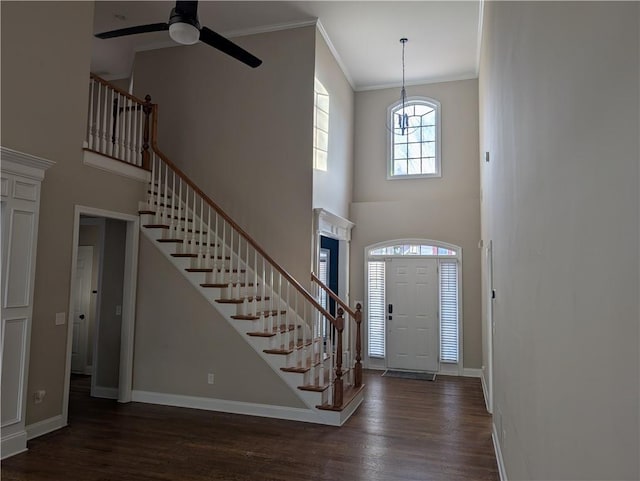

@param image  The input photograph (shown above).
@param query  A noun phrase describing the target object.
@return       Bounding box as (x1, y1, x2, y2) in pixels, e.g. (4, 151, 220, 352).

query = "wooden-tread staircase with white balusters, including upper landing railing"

(87, 75, 364, 425)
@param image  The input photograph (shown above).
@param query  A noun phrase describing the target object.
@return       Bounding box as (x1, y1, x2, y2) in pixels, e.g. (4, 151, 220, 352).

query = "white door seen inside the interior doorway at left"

(71, 246, 93, 374)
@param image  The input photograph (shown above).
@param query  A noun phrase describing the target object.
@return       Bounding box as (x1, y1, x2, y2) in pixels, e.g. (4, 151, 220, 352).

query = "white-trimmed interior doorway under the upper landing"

(63, 206, 139, 423)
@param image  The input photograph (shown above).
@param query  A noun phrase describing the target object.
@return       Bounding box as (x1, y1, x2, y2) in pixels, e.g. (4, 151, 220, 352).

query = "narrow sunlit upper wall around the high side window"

(313, 31, 354, 218)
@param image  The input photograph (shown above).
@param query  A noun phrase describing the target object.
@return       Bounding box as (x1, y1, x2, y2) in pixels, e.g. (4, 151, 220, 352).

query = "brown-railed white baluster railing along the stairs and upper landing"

(86, 74, 362, 410)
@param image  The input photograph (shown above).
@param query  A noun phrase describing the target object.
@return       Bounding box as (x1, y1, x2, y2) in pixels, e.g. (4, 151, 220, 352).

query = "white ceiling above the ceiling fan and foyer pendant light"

(91, 0, 482, 90)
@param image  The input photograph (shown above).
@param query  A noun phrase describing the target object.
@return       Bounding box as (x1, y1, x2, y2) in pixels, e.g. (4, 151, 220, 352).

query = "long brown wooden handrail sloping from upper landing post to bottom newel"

(151, 104, 337, 326)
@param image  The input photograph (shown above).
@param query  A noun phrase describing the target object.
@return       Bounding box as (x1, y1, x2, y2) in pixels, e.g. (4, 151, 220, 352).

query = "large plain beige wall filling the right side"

(480, 2, 640, 480)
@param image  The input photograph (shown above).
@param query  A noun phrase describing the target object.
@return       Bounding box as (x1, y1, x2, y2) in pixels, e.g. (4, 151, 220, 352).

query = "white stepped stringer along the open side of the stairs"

(140, 219, 352, 426)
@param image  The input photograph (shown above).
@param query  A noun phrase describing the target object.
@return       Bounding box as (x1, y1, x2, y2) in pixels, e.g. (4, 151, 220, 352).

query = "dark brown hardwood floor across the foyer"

(0, 371, 498, 481)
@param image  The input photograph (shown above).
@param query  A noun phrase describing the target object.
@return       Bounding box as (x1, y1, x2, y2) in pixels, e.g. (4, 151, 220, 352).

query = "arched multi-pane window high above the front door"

(387, 97, 441, 179)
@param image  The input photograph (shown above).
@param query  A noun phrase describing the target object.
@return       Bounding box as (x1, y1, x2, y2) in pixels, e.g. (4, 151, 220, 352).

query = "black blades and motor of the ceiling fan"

(96, 1, 262, 68)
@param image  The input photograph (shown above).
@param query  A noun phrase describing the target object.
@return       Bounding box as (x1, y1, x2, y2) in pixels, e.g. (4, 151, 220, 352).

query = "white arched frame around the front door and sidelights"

(362, 238, 464, 376)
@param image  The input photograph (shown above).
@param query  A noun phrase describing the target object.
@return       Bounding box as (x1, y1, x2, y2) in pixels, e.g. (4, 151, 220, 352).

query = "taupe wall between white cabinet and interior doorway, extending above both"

(0, 1, 146, 424)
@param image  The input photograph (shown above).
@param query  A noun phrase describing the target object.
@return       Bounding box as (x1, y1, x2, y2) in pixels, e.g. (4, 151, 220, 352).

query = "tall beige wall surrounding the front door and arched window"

(350, 80, 482, 368)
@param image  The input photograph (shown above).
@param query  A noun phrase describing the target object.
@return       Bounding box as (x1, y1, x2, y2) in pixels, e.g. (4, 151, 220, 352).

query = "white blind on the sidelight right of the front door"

(440, 260, 458, 362)
